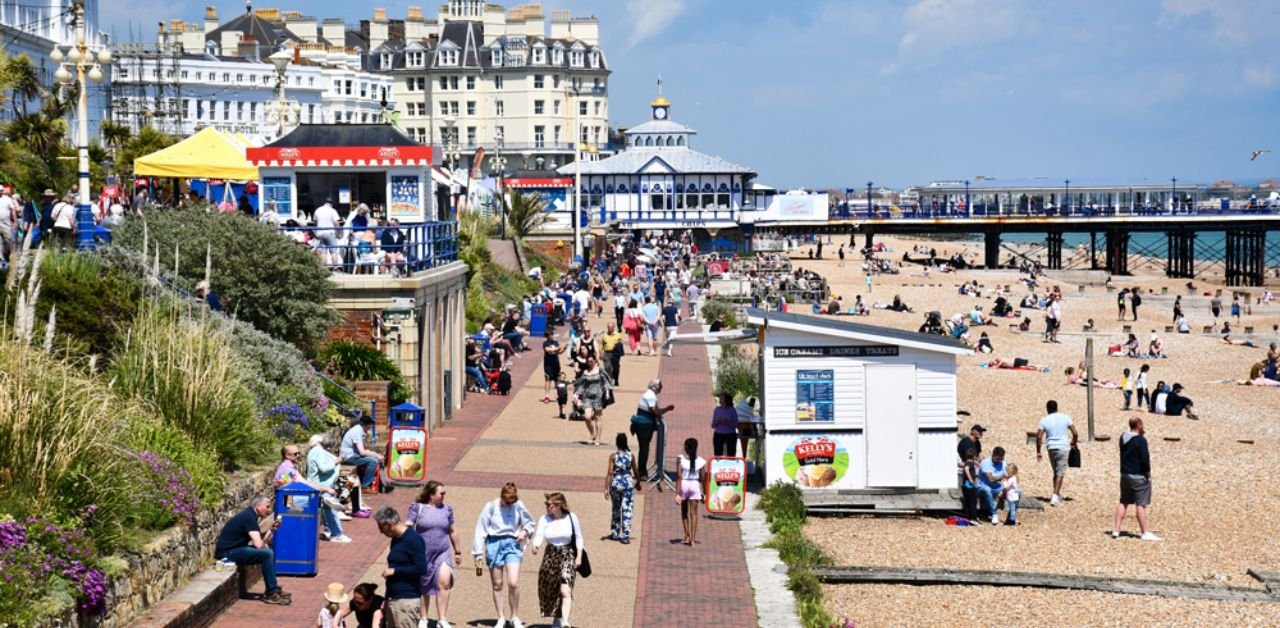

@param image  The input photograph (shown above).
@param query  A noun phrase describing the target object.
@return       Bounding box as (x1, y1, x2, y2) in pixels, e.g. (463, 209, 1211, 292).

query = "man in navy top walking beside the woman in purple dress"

(374, 505, 426, 627)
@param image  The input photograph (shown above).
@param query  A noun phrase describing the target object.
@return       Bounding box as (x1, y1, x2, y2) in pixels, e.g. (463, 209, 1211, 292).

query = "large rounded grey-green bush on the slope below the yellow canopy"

(111, 206, 337, 347)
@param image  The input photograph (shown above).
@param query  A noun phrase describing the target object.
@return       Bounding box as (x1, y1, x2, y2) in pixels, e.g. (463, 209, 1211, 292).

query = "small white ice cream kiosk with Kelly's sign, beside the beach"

(748, 310, 973, 508)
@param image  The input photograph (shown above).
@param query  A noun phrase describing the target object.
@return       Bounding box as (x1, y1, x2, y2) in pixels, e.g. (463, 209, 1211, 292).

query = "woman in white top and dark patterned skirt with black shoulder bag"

(534, 492, 582, 628)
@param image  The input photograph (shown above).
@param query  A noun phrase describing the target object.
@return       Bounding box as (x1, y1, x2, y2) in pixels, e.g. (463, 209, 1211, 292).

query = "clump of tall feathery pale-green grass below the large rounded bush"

(111, 307, 275, 466)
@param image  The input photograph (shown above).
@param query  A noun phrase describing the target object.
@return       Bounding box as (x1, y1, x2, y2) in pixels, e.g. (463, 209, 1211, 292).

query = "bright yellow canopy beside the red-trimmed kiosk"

(133, 127, 257, 180)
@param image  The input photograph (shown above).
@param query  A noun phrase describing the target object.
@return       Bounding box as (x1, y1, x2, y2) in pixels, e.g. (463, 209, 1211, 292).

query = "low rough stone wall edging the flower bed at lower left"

(46, 466, 274, 628)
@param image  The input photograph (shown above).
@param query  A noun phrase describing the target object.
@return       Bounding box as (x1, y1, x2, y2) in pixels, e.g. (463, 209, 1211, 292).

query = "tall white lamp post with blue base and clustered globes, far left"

(49, 0, 111, 251)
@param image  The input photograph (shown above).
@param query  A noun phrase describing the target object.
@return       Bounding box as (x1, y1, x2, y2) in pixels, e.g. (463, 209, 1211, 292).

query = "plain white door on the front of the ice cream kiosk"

(865, 365, 920, 487)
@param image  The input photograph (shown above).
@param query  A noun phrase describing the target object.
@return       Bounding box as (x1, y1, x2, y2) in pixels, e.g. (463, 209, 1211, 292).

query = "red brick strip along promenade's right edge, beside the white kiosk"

(634, 321, 756, 628)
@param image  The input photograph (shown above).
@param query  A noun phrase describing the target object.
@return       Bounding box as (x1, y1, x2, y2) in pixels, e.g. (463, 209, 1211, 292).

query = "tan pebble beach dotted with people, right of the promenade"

(791, 237, 1280, 625)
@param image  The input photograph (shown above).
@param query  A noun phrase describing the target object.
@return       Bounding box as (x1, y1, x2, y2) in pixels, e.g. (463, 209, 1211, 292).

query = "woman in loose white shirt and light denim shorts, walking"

(471, 482, 534, 628)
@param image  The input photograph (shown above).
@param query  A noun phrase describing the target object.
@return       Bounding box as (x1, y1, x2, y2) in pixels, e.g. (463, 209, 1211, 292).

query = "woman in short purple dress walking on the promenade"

(406, 480, 462, 628)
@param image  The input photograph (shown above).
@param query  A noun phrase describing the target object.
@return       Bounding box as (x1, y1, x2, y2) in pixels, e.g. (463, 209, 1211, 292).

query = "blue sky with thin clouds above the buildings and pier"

(100, 0, 1280, 188)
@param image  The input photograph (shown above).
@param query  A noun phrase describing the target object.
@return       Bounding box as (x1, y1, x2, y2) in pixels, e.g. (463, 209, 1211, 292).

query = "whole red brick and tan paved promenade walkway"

(215, 321, 756, 628)
